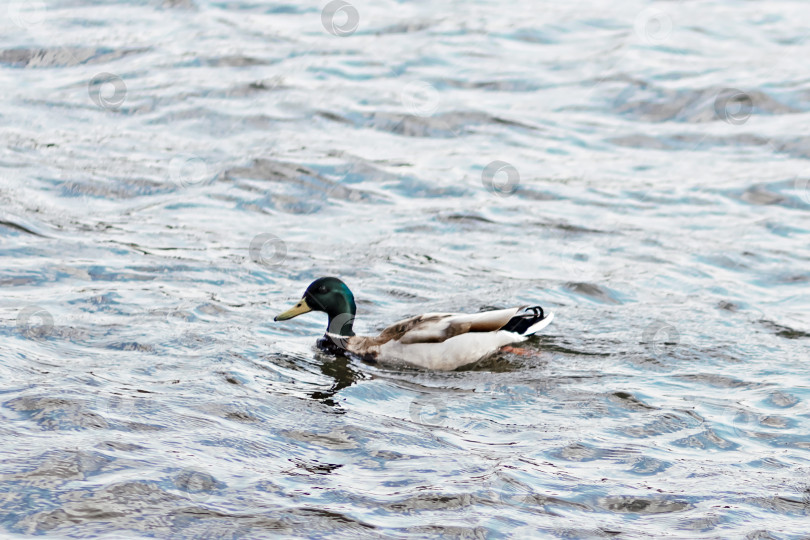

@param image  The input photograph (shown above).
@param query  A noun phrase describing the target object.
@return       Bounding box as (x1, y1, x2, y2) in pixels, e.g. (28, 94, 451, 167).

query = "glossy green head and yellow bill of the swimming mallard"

(274, 277, 357, 336)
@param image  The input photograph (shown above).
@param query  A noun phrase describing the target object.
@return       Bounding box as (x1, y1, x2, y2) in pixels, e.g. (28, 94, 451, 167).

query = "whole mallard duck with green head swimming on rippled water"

(274, 277, 554, 370)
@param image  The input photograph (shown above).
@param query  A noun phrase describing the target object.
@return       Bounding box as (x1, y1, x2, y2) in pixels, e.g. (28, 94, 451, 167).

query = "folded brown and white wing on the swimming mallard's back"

(377, 306, 551, 345)
